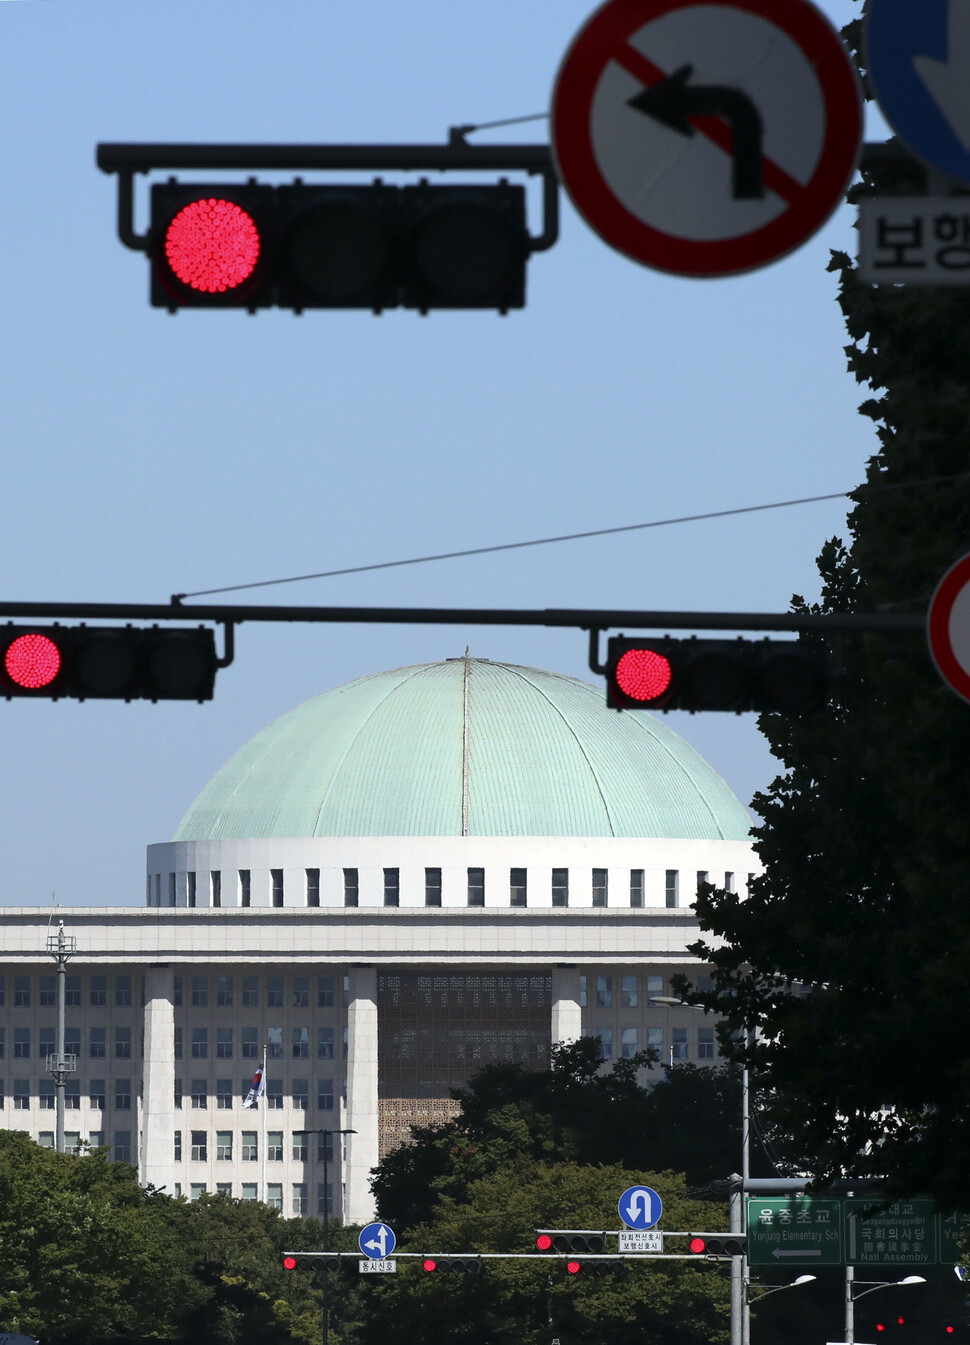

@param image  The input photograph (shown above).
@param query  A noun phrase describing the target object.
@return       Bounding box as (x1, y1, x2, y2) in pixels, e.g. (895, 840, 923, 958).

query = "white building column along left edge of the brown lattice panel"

(340, 967, 379, 1224)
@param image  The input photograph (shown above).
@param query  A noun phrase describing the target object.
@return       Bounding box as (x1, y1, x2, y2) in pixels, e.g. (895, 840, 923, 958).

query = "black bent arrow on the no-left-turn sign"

(627, 65, 764, 200)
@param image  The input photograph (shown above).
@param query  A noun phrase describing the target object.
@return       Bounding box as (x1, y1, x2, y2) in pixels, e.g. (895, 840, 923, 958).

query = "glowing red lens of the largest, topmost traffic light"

(165, 196, 260, 295)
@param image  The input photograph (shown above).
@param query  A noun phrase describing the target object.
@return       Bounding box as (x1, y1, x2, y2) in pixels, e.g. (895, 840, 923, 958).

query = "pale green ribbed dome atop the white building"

(175, 658, 751, 841)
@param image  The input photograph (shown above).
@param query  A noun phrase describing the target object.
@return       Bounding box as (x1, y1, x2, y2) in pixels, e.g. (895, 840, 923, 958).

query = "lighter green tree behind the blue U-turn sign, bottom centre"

(342, 1158, 729, 1345)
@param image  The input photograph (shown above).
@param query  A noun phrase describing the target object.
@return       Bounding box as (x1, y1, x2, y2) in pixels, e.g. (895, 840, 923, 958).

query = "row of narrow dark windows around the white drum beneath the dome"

(147, 868, 753, 909)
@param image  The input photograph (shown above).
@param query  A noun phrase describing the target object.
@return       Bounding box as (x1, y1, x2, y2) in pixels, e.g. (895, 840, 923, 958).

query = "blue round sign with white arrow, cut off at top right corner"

(865, 0, 970, 183)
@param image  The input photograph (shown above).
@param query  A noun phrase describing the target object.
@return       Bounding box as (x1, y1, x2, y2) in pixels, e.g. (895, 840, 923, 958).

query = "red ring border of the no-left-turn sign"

(550, 0, 862, 277)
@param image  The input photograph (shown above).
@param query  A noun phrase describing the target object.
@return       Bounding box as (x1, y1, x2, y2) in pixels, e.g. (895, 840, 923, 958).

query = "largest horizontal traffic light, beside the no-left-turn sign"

(148, 179, 530, 312)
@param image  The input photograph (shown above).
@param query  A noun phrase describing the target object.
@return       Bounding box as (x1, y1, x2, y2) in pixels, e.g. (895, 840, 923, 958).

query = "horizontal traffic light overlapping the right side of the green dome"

(605, 635, 826, 714)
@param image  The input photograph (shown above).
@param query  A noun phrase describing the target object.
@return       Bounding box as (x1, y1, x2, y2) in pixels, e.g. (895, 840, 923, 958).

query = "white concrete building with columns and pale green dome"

(0, 658, 757, 1221)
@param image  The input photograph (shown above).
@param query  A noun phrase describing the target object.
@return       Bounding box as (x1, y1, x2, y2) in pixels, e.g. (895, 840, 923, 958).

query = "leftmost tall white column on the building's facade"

(139, 966, 179, 1196)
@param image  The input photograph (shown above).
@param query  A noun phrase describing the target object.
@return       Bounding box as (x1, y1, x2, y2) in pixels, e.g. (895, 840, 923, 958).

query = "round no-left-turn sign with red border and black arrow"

(550, 0, 862, 276)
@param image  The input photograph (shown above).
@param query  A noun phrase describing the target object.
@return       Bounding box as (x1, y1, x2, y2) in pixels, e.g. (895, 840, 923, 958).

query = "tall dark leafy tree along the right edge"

(680, 121, 970, 1209)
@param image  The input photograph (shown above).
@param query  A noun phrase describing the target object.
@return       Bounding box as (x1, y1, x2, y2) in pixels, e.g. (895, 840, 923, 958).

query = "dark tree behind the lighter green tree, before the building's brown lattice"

(374, 1038, 741, 1228)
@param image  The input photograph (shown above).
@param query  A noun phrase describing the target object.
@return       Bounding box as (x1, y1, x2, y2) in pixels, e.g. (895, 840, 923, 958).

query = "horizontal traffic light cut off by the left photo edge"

(0, 624, 218, 701)
